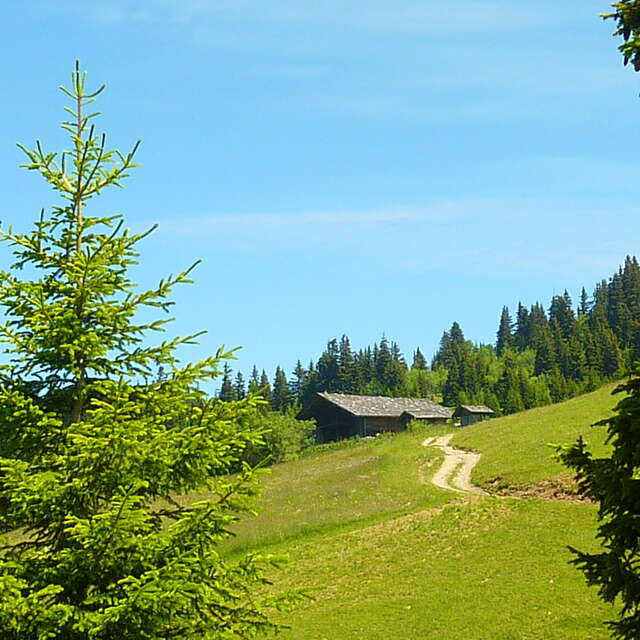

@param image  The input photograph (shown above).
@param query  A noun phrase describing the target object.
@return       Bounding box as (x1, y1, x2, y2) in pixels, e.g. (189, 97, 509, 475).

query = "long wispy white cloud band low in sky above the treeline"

(148, 198, 640, 273)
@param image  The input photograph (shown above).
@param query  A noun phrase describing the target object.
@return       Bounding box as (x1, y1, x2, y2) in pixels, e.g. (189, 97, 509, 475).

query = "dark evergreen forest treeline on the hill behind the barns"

(219, 257, 640, 414)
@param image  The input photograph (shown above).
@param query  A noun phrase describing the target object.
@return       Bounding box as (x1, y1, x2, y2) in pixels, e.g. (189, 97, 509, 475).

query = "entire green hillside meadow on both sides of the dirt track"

(224, 387, 615, 640)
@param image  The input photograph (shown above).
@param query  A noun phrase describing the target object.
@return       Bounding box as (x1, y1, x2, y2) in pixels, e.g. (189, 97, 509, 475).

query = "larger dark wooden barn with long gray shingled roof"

(298, 392, 452, 443)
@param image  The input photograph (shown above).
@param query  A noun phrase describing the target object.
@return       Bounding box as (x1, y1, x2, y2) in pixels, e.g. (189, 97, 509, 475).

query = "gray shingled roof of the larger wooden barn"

(318, 392, 452, 418)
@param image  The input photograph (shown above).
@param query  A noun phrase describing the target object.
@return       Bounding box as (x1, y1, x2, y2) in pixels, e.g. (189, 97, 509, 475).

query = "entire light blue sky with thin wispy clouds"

(0, 0, 640, 384)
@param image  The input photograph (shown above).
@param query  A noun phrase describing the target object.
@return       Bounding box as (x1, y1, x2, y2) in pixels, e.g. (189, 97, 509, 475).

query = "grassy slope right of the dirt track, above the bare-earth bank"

(452, 384, 619, 488)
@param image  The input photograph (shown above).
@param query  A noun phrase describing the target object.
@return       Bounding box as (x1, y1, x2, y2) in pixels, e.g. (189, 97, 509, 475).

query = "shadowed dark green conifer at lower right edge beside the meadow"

(560, 370, 640, 640)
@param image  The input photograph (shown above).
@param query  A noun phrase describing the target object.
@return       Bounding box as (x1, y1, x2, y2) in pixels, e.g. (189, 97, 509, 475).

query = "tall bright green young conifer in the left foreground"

(0, 63, 296, 640)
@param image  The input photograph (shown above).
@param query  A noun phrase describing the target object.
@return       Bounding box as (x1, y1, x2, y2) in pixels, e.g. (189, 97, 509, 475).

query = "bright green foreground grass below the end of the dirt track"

(278, 498, 612, 640)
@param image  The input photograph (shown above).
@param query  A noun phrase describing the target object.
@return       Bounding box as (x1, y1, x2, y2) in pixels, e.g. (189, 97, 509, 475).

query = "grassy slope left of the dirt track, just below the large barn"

(223, 428, 450, 553)
